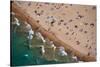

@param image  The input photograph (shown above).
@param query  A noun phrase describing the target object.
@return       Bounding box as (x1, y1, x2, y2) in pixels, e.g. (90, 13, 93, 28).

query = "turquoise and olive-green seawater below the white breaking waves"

(11, 22, 75, 66)
